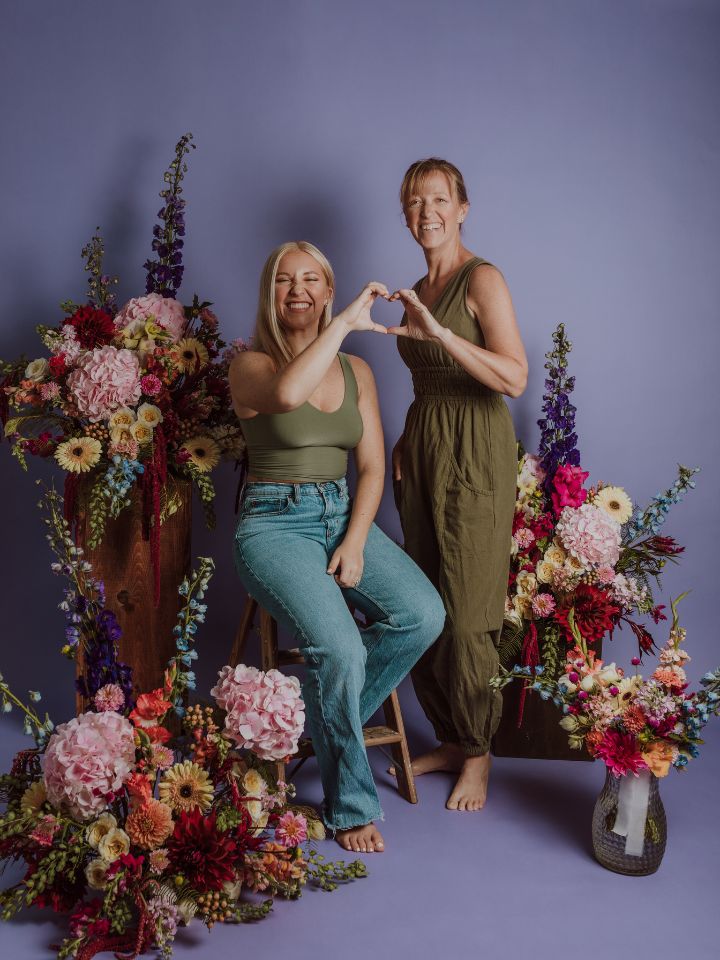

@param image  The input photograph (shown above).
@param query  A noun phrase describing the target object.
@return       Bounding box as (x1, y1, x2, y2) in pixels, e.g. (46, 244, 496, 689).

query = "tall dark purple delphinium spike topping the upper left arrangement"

(143, 133, 195, 299)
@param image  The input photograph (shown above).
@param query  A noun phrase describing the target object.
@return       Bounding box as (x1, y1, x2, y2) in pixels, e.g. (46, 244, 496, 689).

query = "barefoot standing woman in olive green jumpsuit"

(388, 158, 527, 810)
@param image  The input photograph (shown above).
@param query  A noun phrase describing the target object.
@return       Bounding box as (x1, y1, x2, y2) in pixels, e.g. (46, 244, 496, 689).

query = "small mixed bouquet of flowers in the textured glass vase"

(492, 594, 720, 777)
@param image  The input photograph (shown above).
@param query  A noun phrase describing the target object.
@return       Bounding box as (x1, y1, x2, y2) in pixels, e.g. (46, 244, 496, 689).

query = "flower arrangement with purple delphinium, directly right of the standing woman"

(500, 324, 697, 724)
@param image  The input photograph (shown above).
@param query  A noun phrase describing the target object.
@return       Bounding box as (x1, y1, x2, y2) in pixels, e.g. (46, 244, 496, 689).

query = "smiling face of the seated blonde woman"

(275, 250, 332, 330)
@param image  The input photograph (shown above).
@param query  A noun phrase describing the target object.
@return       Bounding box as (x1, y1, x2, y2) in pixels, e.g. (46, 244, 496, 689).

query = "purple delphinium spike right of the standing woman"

(538, 323, 580, 495)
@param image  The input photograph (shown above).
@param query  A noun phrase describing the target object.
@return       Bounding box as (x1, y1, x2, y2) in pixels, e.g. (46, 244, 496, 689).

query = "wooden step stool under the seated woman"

(230, 596, 417, 803)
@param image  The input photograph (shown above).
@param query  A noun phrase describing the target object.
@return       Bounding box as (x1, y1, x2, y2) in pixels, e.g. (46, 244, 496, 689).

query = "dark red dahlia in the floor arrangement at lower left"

(166, 807, 238, 890)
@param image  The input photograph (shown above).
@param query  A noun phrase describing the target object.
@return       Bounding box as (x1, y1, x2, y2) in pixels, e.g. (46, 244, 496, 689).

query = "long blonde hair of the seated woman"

(253, 240, 335, 370)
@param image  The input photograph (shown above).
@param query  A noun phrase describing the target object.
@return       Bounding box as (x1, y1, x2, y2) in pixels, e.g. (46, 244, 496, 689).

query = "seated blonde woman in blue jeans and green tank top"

(230, 241, 445, 852)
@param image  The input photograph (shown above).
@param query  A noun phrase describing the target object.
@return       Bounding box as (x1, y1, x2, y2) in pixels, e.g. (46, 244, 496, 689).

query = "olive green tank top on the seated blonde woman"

(240, 353, 363, 483)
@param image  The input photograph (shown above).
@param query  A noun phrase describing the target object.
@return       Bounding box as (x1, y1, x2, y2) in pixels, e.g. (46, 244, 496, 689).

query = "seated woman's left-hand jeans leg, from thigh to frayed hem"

(235, 527, 382, 830)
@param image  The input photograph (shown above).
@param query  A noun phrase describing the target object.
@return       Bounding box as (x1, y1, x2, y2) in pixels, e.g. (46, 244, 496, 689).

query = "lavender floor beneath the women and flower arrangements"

(0, 689, 720, 960)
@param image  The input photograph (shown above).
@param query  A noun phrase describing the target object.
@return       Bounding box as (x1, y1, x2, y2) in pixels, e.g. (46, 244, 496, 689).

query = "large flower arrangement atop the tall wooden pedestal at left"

(0, 134, 244, 595)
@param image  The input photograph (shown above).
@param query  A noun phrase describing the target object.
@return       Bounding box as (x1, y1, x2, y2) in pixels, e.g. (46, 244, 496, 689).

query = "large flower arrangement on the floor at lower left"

(0, 491, 365, 960)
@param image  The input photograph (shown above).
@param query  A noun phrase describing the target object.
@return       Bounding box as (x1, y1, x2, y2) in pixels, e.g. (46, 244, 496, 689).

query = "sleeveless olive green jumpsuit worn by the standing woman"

(398, 257, 517, 756)
